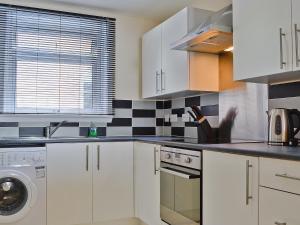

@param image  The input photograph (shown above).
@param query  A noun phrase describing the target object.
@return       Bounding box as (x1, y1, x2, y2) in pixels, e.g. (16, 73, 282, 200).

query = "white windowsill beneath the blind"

(0, 114, 113, 123)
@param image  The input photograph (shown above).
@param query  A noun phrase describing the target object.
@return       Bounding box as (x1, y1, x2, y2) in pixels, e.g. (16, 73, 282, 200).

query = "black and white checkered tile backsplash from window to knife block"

(0, 94, 218, 137)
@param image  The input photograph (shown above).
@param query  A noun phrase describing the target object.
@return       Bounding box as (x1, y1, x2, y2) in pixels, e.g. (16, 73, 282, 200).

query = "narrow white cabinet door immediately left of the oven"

(134, 142, 162, 225)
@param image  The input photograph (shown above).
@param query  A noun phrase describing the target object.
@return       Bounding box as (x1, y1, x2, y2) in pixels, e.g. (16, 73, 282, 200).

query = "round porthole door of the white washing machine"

(0, 170, 37, 224)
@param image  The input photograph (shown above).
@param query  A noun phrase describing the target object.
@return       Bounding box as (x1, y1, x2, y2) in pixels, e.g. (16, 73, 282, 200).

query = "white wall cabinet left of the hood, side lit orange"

(142, 7, 240, 98)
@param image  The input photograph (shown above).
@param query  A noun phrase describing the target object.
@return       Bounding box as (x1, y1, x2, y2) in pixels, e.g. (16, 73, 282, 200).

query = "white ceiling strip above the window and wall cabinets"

(51, 0, 232, 21)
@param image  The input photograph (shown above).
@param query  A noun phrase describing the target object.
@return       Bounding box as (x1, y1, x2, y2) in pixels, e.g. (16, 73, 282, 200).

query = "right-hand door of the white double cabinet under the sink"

(93, 142, 134, 223)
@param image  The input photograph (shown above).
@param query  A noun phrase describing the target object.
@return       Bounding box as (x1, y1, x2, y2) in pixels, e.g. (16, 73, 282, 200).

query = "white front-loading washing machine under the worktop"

(0, 145, 46, 225)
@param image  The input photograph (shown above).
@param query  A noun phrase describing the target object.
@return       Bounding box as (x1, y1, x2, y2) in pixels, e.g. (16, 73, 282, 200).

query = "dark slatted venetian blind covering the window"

(0, 5, 115, 115)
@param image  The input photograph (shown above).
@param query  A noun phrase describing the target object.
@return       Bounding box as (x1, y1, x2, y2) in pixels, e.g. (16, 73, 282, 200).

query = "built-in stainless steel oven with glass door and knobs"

(160, 147, 202, 225)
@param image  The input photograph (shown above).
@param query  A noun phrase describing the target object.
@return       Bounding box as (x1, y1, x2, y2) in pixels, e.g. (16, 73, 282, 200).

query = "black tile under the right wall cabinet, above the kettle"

(269, 82, 300, 99)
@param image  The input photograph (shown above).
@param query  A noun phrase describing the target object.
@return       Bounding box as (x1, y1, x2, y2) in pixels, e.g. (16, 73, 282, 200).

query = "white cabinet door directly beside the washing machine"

(47, 143, 92, 225)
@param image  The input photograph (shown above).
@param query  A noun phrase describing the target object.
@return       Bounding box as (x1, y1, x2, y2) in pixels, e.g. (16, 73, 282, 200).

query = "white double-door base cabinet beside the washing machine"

(47, 142, 134, 225)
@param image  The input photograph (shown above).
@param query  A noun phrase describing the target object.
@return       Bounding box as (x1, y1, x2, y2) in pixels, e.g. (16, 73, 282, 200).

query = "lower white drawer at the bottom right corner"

(259, 187, 300, 225)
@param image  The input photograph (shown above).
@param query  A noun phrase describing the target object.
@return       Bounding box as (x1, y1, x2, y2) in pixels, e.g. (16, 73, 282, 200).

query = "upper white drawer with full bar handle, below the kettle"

(259, 158, 300, 194)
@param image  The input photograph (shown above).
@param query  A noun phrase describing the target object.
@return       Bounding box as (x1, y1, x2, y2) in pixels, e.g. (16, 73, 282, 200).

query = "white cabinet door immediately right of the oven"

(203, 151, 258, 225)
